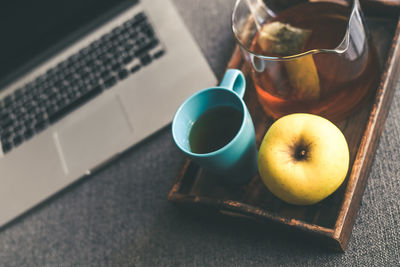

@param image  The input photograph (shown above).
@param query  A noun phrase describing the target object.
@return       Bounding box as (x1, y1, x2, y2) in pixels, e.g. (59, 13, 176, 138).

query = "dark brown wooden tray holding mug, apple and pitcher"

(168, 4, 400, 251)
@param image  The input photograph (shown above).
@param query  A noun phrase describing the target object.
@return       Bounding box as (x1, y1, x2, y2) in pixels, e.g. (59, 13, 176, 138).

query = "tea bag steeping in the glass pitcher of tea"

(257, 21, 320, 100)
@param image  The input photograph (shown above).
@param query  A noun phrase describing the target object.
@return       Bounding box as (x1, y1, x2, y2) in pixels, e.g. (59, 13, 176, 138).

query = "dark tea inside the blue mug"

(189, 106, 243, 154)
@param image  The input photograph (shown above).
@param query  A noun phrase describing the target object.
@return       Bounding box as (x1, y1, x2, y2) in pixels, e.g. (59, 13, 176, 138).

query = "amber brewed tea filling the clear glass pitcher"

(250, 2, 379, 120)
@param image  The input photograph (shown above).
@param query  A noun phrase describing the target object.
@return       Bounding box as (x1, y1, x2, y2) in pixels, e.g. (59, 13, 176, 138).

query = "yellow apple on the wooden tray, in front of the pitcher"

(258, 113, 349, 205)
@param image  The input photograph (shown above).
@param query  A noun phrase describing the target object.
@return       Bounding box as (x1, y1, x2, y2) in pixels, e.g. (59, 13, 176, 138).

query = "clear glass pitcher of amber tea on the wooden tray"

(232, 0, 379, 121)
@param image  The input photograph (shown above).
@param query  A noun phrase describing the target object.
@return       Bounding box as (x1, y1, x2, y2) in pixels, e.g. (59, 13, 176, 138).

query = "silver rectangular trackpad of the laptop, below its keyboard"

(53, 96, 132, 175)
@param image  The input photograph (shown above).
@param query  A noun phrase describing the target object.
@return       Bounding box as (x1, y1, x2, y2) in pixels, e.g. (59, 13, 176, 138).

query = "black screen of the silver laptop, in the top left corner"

(0, 0, 130, 85)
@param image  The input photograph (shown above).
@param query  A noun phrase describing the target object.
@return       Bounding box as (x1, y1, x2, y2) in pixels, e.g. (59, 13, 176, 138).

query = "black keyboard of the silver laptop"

(0, 13, 164, 153)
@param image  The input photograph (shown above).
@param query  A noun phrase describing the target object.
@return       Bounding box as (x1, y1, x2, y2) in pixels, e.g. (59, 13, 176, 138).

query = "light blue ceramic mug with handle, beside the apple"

(172, 69, 257, 183)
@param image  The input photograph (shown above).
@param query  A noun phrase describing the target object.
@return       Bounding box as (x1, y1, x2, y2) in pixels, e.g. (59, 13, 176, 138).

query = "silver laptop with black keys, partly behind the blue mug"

(0, 0, 216, 226)
